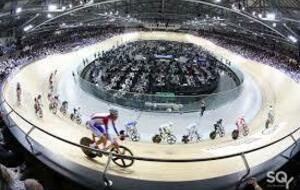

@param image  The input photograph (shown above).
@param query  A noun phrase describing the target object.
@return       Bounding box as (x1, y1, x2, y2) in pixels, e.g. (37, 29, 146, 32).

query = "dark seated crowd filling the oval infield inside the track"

(83, 41, 219, 94)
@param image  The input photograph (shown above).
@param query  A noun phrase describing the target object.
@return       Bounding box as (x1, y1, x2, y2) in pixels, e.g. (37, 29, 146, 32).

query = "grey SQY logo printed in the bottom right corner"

(267, 171, 294, 190)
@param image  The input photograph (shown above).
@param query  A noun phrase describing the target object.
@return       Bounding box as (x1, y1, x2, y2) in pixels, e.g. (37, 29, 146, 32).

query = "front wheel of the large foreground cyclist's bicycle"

(110, 146, 134, 168)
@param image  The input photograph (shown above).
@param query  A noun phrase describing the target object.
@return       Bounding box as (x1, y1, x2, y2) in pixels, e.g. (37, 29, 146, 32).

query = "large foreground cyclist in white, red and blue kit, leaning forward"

(87, 109, 120, 148)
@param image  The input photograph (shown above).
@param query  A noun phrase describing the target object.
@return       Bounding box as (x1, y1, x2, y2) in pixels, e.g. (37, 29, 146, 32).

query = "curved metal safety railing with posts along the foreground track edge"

(0, 100, 300, 189)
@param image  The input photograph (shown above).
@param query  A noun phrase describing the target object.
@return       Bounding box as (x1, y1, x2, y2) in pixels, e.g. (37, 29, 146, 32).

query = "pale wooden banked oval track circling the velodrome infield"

(3, 32, 300, 189)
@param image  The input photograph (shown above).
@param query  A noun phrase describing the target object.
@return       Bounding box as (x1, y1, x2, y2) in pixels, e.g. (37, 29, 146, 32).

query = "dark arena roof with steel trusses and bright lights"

(0, 0, 300, 42)
